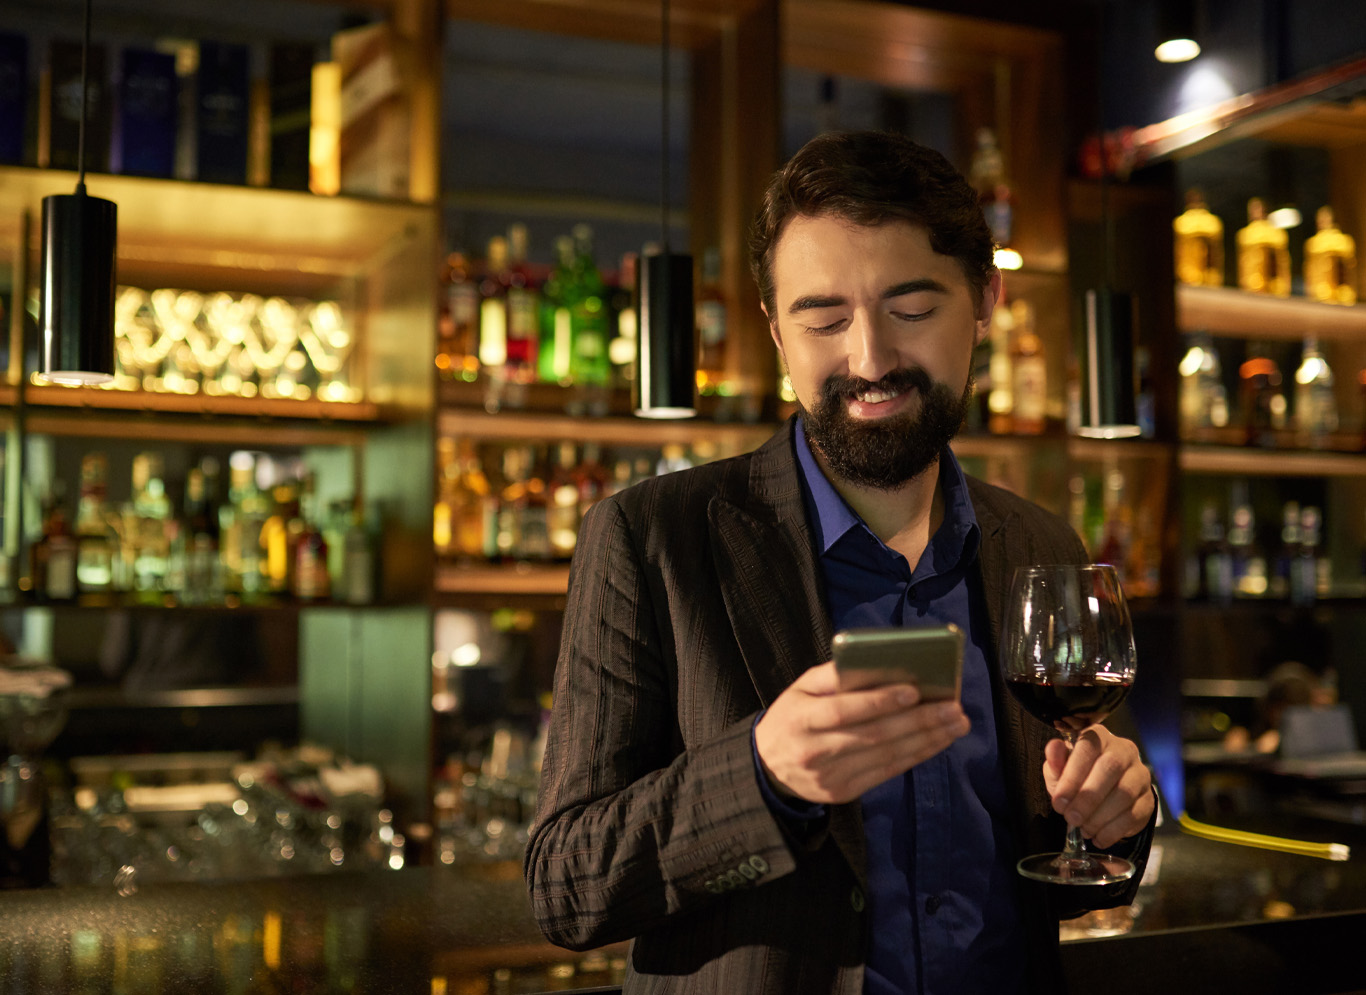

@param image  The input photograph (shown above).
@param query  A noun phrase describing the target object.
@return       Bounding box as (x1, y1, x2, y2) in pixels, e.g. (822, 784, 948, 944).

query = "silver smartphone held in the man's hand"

(831, 623, 963, 701)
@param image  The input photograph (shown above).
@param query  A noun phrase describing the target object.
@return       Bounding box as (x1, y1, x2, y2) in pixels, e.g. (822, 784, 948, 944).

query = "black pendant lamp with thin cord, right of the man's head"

(1076, 2, 1141, 439)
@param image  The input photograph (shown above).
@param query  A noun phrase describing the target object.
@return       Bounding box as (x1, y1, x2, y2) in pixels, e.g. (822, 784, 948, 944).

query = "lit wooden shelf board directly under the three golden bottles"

(1176, 284, 1366, 342)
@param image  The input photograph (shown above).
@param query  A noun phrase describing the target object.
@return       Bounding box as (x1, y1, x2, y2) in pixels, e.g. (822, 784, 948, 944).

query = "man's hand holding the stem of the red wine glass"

(1044, 726, 1156, 850)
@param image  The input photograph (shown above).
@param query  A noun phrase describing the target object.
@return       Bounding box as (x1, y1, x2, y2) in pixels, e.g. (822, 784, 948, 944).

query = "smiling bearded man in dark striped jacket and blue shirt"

(526, 133, 1154, 995)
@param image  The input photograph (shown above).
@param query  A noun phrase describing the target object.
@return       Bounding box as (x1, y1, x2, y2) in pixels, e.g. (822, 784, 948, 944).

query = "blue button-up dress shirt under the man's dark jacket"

(755, 422, 1026, 995)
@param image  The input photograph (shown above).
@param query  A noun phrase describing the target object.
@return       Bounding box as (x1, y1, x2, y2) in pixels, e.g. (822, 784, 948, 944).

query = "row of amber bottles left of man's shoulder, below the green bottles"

(432, 436, 731, 564)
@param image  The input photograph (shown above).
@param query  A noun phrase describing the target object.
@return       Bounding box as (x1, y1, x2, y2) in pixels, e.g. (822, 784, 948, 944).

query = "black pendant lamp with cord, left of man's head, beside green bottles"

(632, 0, 697, 418)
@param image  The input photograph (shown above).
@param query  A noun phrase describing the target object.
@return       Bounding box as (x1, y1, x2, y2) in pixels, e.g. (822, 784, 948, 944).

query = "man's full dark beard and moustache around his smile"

(798, 366, 973, 491)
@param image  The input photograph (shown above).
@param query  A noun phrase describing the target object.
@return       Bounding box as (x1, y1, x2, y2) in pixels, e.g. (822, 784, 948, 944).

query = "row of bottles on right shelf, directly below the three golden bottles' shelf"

(1179, 332, 1366, 450)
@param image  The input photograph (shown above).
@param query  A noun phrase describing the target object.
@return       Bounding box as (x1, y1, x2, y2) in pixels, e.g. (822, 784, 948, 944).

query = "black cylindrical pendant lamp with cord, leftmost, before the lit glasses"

(38, 0, 119, 384)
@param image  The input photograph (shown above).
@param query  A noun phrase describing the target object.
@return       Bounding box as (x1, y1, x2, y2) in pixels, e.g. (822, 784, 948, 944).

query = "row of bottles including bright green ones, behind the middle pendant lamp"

(436, 223, 732, 404)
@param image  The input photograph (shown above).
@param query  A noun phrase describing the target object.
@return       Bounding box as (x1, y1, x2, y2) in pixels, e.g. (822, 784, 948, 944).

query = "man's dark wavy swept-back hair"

(750, 131, 996, 320)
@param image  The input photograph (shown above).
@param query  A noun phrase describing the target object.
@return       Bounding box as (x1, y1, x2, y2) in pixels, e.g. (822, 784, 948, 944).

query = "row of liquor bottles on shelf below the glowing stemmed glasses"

(26, 450, 376, 605)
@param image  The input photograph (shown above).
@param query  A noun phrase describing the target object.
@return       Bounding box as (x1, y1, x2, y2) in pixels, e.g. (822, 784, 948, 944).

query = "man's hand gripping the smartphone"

(754, 663, 968, 805)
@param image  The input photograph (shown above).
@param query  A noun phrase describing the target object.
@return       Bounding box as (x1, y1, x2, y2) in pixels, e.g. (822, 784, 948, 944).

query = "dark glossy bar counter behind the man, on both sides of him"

(8, 827, 1366, 995)
